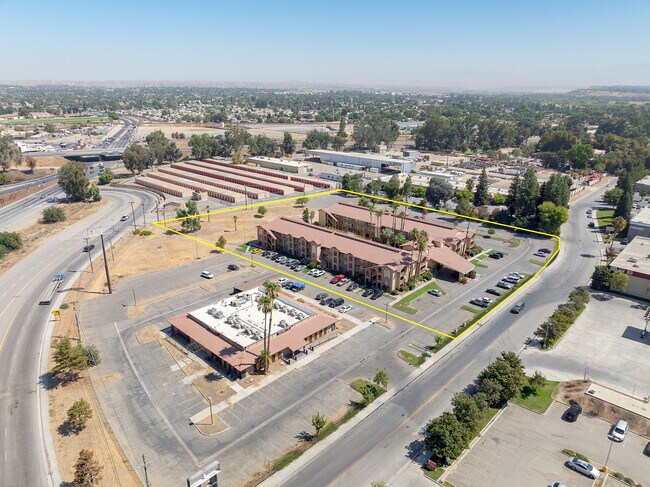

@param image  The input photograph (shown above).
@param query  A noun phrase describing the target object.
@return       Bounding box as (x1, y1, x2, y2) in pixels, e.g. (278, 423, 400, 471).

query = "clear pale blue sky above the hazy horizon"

(0, 0, 650, 89)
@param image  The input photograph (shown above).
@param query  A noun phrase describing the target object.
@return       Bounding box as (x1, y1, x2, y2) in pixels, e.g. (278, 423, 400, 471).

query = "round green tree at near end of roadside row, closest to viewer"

(424, 411, 472, 461)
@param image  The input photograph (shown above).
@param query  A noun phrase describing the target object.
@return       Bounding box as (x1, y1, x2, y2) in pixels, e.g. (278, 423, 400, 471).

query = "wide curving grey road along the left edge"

(0, 189, 155, 487)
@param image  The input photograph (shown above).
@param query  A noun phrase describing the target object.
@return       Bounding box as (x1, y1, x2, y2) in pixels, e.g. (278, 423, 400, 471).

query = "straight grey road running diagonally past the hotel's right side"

(270, 187, 605, 487)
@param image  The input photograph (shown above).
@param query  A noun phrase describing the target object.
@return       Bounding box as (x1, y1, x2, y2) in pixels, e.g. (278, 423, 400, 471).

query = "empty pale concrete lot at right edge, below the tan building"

(521, 295, 650, 398)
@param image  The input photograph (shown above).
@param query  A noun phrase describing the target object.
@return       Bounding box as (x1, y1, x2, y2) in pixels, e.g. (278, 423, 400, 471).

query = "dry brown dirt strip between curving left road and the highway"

(0, 200, 107, 274)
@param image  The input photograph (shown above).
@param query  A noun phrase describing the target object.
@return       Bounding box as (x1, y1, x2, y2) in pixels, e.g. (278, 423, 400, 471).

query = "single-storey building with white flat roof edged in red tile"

(168, 283, 338, 378)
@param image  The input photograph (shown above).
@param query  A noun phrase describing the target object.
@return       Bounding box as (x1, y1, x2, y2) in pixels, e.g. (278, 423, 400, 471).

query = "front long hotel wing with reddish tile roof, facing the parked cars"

(257, 217, 427, 291)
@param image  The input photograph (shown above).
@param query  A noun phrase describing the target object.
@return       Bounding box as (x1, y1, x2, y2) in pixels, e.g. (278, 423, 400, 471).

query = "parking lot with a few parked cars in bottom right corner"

(448, 402, 650, 487)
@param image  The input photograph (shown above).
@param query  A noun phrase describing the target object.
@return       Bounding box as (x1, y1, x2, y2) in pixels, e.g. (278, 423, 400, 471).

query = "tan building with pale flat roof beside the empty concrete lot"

(609, 237, 650, 299)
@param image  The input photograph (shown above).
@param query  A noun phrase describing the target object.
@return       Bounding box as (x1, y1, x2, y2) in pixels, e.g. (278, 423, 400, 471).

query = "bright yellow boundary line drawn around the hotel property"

(153, 189, 561, 340)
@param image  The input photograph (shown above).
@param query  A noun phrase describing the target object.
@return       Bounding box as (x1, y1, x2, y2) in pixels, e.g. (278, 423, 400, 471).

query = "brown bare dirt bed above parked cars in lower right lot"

(555, 380, 650, 438)
